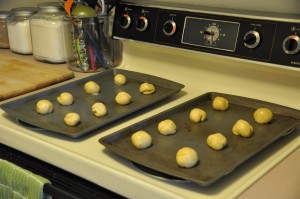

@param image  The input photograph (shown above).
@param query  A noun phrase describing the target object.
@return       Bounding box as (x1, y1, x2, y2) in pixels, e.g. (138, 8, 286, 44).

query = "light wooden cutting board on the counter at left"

(0, 57, 74, 101)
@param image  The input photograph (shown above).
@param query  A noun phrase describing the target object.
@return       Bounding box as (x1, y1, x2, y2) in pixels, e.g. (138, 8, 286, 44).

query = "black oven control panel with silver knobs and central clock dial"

(113, 4, 300, 67)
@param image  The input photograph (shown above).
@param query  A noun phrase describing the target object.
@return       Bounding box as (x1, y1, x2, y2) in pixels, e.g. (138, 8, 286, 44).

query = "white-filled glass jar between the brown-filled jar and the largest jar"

(7, 7, 36, 54)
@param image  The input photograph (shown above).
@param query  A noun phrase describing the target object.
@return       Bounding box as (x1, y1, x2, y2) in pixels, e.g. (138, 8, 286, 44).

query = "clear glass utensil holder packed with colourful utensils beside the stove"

(64, 15, 122, 72)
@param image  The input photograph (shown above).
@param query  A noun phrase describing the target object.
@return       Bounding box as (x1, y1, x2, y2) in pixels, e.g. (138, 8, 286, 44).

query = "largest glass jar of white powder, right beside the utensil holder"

(30, 2, 66, 63)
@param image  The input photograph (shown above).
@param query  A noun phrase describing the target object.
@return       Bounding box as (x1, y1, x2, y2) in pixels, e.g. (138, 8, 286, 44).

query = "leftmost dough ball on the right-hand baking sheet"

(131, 130, 152, 149)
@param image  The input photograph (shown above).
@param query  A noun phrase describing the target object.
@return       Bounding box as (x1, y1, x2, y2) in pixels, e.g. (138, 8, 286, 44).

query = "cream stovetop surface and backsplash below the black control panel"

(0, 42, 300, 198)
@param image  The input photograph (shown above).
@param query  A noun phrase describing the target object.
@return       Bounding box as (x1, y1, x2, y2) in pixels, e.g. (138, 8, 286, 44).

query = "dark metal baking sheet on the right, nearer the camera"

(99, 93, 300, 186)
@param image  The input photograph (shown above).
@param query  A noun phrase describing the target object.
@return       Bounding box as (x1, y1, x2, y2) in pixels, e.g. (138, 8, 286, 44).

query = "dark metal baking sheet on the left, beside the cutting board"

(1, 69, 184, 138)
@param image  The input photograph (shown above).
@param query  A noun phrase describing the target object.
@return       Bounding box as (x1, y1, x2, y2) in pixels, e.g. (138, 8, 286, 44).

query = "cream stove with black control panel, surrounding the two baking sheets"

(0, 1, 300, 198)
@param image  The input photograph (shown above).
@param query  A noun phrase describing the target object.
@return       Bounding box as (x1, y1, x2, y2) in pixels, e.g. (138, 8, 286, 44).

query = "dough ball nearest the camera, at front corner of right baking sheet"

(176, 147, 198, 168)
